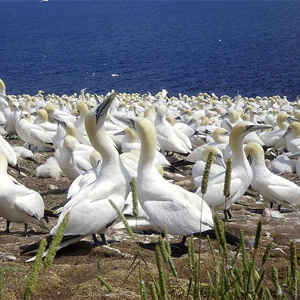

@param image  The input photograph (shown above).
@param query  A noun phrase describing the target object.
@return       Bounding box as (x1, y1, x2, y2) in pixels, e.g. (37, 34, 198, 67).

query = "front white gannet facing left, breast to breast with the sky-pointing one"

(134, 118, 214, 243)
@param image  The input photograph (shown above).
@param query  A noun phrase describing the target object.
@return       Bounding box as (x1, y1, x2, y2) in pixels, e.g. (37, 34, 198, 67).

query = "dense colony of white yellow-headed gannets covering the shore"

(0, 80, 300, 260)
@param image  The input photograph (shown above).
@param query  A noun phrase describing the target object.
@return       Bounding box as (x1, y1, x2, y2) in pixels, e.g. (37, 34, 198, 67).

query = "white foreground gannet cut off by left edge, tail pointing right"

(0, 152, 48, 235)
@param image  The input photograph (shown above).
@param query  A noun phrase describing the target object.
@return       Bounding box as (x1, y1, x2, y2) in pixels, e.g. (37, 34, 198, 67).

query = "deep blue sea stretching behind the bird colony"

(0, 0, 300, 101)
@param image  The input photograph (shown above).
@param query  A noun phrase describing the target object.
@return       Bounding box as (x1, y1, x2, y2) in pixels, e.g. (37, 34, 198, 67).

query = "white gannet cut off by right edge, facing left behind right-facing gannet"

(244, 142, 300, 211)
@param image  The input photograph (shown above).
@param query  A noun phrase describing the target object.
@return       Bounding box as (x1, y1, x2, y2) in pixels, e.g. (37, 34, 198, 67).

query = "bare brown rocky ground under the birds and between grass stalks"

(0, 140, 300, 299)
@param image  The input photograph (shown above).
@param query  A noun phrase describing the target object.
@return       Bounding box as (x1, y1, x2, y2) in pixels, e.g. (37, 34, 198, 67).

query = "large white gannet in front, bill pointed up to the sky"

(22, 94, 131, 261)
